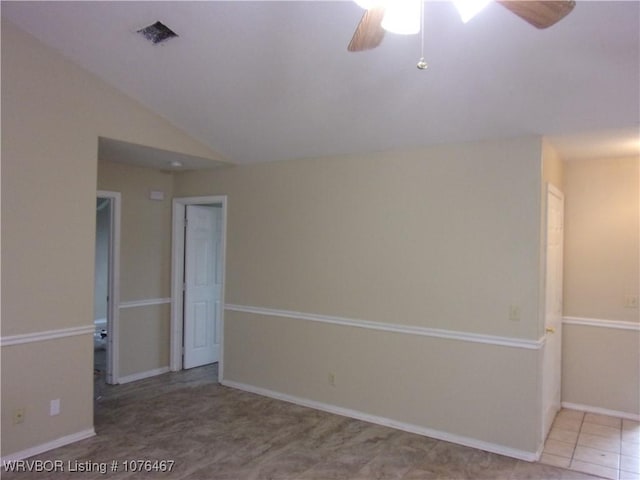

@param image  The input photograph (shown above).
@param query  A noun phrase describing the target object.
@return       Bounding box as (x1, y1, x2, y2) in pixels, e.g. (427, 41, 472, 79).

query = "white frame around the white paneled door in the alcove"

(169, 195, 227, 381)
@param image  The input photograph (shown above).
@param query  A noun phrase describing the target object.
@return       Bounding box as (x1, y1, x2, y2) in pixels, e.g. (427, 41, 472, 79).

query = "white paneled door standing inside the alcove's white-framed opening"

(183, 205, 222, 368)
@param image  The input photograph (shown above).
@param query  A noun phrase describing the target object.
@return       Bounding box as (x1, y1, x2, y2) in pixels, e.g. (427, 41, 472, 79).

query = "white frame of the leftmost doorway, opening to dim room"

(96, 190, 122, 384)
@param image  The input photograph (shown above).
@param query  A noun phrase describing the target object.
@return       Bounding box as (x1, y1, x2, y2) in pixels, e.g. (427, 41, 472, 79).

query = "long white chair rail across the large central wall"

(225, 304, 544, 350)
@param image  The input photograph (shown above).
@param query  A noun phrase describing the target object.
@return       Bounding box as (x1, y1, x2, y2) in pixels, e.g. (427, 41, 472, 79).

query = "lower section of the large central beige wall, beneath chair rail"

(225, 312, 540, 456)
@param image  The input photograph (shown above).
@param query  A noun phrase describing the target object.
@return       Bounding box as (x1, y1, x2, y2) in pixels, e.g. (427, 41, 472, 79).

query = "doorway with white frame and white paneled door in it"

(170, 196, 227, 379)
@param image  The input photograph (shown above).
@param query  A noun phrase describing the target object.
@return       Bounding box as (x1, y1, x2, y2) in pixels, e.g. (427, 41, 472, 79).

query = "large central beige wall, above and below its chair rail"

(175, 138, 542, 453)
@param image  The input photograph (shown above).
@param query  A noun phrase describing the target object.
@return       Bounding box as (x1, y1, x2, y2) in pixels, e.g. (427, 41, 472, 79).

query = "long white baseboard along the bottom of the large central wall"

(221, 380, 542, 462)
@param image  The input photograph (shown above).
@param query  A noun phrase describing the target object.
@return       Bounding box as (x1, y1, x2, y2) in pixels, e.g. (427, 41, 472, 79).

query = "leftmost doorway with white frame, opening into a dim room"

(93, 190, 120, 384)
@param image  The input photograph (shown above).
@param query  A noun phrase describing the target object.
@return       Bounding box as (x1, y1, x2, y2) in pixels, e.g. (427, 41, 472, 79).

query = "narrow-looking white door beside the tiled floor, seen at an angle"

(542, 185, 564, 437)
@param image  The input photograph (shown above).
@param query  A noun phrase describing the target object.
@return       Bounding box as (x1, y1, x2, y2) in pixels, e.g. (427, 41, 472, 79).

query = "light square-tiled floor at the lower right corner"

(540, 409, 640, 480)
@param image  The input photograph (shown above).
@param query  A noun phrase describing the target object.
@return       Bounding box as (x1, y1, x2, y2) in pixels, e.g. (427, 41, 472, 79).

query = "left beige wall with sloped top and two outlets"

(1, 18, 217, 456)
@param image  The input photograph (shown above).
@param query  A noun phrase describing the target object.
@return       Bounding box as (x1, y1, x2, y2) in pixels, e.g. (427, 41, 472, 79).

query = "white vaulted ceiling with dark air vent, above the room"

(2, 0, 640, 163)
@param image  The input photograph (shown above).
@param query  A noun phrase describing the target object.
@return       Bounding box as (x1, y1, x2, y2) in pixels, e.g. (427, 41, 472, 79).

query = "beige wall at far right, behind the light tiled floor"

(562, 158, 640, 415)
